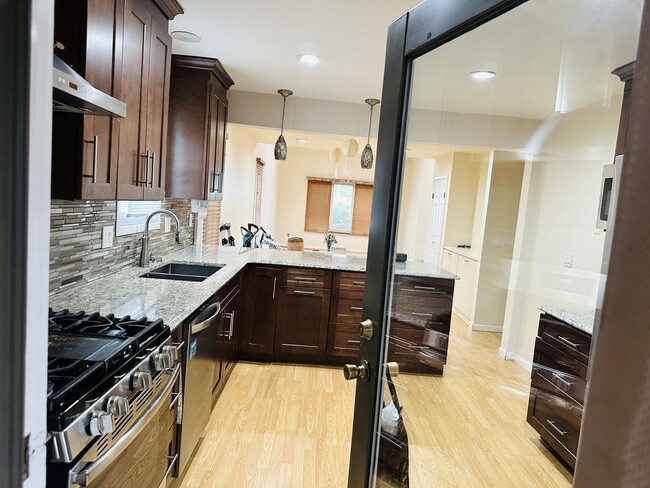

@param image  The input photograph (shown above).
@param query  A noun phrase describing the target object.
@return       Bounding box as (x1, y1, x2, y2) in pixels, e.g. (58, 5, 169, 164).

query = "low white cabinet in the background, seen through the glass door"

(442, 248, 478, 327)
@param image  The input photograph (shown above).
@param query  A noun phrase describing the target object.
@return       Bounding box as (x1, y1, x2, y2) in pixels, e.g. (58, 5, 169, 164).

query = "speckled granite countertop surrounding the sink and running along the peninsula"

(50, 245, 457, 330)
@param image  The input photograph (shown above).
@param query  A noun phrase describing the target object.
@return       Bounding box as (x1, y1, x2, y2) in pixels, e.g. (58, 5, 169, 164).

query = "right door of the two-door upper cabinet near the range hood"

(144, 18, 172, 200)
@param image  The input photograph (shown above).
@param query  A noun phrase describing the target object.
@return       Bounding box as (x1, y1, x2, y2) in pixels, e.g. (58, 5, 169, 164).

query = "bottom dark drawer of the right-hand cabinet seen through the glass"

(529, 386, 581, 466)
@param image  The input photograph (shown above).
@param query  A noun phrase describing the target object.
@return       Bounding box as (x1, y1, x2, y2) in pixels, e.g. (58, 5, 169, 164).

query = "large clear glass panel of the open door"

(353, 0, 643, 488)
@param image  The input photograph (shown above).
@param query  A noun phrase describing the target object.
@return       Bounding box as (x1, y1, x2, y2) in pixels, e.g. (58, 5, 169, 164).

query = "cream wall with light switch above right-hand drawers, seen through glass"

(501, 98, 621, 363)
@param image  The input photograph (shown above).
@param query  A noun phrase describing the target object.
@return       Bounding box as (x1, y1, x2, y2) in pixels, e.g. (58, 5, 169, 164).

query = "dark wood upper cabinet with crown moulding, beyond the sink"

(166, 55, 234, 200)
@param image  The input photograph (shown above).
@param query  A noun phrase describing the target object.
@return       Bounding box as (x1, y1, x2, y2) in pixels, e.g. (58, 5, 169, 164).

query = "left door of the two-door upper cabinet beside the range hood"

(117, 0, 151, 200)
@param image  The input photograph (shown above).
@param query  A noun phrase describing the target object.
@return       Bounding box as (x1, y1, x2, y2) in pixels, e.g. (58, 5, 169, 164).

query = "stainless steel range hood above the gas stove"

(52, 54, 126, 117)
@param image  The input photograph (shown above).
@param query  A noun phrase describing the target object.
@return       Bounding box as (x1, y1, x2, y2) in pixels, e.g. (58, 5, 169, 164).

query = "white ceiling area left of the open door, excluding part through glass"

(169, 0, 419, 103)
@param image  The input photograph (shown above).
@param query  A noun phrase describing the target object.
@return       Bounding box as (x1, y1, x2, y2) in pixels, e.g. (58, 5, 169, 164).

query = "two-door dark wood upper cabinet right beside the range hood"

(117, 0, 171, 200)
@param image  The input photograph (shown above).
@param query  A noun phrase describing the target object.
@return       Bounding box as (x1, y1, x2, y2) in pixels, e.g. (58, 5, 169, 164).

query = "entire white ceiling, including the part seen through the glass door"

(170, 0, 643, 124)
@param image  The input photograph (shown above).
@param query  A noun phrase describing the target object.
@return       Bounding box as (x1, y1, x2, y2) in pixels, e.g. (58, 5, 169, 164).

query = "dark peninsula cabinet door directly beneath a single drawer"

(273, 287, 330, 354)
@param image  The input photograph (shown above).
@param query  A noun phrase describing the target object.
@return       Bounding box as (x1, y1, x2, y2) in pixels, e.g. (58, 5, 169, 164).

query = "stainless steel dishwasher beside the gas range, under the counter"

(179, 297, 221, 475)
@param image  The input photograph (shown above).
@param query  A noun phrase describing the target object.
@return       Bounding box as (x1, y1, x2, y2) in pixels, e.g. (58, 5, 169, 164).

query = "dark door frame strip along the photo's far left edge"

(0, 0, 31, 487)
